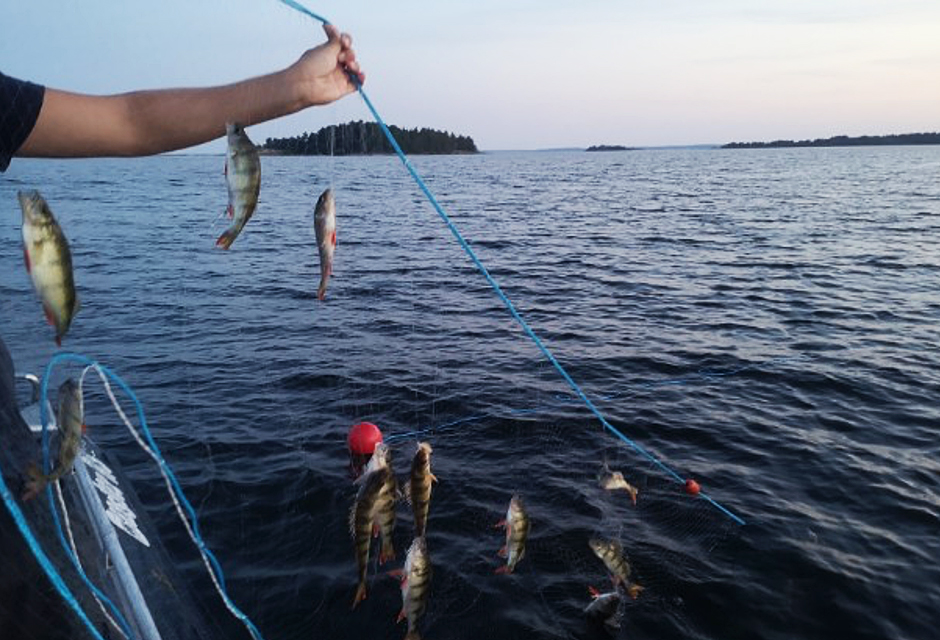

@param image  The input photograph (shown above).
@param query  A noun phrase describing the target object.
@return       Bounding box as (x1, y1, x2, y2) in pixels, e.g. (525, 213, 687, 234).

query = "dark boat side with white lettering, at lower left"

(0, 342, 224, 640)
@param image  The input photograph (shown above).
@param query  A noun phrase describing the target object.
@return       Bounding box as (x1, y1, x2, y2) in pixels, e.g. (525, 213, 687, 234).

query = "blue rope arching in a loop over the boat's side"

(40, 353, 263, 640)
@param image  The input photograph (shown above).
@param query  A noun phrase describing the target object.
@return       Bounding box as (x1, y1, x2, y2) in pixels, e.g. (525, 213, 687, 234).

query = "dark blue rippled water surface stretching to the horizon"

(0, 147, 940, 640)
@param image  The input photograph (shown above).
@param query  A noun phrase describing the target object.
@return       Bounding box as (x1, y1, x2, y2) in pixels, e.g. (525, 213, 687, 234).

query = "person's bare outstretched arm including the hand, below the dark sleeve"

(17, 25, 365, 158)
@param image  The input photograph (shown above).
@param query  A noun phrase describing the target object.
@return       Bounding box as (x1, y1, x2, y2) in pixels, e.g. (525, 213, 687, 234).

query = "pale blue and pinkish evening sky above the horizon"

(0, 0, 940, 151)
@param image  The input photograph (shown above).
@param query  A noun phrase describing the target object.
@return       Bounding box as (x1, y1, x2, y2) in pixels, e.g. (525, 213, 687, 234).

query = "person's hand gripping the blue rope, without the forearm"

(290, 24, 366, 106)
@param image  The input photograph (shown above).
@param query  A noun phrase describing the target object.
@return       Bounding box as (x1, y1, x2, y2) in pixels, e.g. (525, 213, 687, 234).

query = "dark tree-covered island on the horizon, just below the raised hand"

(261, 120, 477, 156)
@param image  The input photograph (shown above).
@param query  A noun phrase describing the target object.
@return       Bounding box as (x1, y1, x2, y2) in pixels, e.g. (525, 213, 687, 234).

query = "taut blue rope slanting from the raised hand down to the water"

(279, 0, 744, 525)
